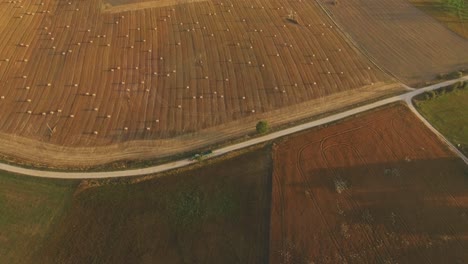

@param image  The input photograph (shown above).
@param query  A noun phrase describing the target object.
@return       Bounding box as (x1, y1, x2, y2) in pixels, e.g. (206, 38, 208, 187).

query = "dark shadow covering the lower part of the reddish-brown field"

(271, 158, 468, 263)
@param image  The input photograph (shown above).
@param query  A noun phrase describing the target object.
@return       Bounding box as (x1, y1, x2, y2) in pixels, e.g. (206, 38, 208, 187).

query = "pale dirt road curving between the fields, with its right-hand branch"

(0, 77, 468, 179)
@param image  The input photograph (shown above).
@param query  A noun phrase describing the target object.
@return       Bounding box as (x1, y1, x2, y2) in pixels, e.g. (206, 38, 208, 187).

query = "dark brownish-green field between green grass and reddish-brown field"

(36, 148, 272, 264)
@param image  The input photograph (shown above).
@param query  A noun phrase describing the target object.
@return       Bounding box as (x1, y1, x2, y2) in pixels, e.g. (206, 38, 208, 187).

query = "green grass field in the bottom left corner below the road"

(0, 172, 77, 264)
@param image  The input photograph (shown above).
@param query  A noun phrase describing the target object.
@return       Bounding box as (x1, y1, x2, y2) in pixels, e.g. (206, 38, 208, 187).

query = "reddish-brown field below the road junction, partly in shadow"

(270, 105, 468, 263)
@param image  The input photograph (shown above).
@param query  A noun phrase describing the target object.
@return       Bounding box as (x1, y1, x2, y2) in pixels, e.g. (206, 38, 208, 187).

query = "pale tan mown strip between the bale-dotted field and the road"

(0, 84, 405, 167)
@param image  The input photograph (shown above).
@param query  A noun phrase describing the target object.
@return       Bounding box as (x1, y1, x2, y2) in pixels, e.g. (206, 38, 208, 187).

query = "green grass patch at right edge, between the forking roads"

(417, 88, 468, 155)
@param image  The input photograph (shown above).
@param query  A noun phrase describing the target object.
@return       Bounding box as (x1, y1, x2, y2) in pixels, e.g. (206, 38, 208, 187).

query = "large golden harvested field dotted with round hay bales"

(0, 0, 392, 148)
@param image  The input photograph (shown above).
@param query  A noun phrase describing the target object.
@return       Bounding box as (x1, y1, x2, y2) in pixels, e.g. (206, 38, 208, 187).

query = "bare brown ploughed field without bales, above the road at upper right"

(320, 0, 468, 86)
